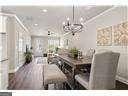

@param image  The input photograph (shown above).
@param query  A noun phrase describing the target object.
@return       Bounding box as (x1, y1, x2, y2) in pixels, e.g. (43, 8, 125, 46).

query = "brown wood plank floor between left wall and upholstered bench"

(8, 58, 44, 90)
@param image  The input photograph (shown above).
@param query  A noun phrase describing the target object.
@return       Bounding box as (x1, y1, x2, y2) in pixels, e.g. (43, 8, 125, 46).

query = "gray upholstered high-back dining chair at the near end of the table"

(75, 51, 120, 90)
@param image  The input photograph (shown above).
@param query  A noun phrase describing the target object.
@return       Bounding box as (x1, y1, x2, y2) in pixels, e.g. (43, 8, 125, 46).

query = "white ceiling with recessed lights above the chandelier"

(2, 6, 112, 36)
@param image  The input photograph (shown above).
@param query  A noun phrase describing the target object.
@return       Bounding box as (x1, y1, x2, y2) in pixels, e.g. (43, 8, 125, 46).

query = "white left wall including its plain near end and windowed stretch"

(6, 16, 31, 73)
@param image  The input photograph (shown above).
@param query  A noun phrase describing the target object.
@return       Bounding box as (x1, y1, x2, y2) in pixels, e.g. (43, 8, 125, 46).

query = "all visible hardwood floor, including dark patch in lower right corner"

(8, 58, 128, 90)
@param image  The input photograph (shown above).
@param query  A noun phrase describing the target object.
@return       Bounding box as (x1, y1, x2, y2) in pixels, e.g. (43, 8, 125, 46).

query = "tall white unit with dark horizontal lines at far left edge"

(0, 15, 8, 90)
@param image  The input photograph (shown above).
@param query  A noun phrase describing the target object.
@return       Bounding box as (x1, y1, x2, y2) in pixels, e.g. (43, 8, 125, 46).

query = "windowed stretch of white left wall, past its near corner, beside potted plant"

(14, 18, 31, 68)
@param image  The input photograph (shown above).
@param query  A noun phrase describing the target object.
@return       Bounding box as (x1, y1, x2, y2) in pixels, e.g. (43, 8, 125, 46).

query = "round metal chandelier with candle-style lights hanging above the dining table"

(63, 5, 84, 35)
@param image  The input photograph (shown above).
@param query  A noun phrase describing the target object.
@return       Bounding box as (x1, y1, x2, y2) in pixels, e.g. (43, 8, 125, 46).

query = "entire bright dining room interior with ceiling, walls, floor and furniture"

(0, 5, 128, 90)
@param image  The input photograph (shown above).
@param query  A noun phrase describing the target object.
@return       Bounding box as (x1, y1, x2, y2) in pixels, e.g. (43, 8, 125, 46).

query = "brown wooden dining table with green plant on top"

(56, 54, 92, 89)
